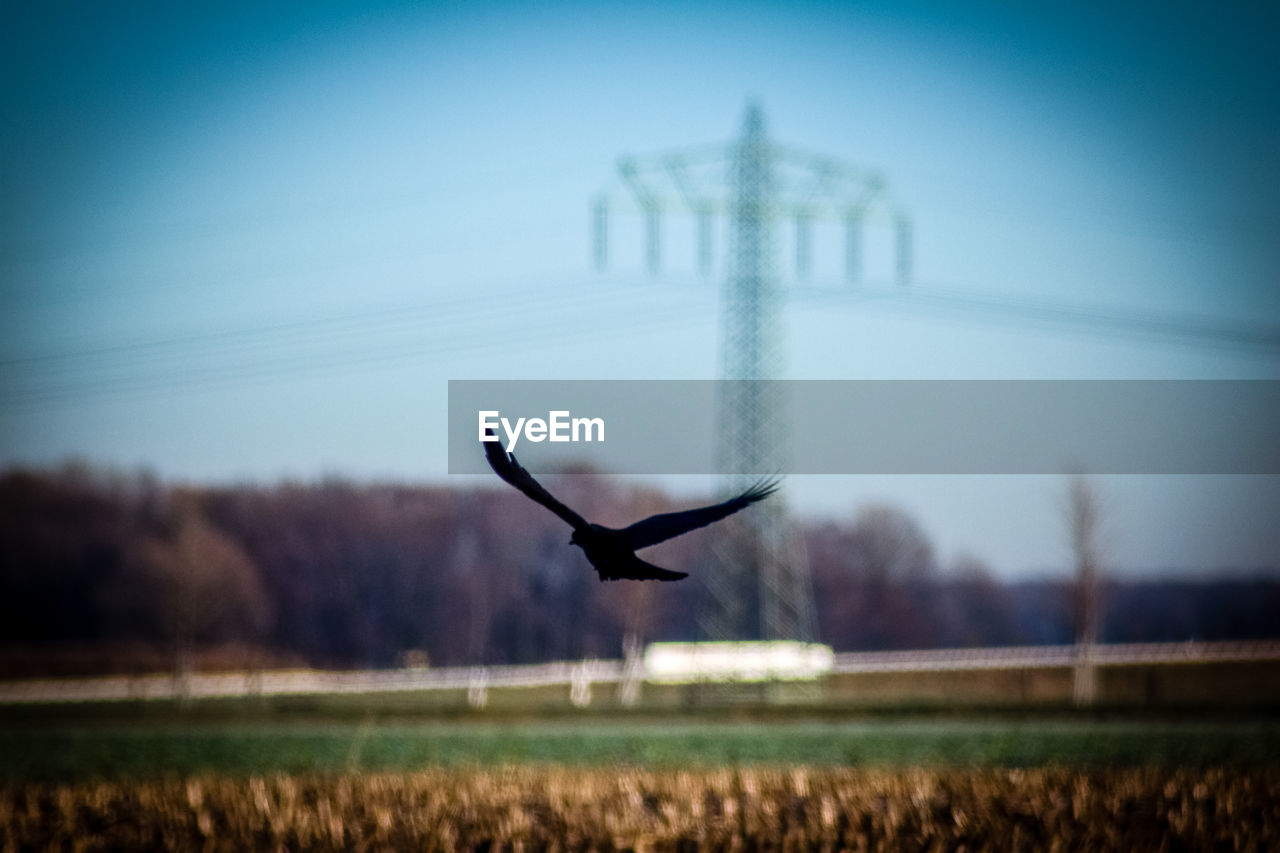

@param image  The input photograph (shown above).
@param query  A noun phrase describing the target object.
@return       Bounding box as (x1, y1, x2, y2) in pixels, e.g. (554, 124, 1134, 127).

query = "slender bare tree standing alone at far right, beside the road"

(1066, 474, 1102, 706)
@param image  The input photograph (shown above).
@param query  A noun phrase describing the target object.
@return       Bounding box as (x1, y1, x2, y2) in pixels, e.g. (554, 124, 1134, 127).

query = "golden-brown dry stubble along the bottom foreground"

(0, 766, 1280, 850)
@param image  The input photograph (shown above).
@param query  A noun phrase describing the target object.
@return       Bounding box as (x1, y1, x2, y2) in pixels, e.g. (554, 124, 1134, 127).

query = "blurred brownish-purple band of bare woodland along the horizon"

(0, 465, 1280, 676)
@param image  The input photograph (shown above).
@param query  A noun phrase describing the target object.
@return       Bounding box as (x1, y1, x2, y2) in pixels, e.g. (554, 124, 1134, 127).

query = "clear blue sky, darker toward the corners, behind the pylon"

(0, 3, 1280, 574)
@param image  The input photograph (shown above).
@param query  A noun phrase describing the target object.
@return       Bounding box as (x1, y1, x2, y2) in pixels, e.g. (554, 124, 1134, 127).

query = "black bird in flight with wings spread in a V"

(484, 430, 778, 581)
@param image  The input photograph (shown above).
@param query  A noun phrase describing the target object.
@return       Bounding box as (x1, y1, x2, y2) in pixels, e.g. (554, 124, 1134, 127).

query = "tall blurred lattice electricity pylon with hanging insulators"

(594, 105, 911, 642)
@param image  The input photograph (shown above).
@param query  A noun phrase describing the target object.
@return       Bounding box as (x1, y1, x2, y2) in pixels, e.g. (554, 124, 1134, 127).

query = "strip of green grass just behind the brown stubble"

(0, 716, 1280, 781)
